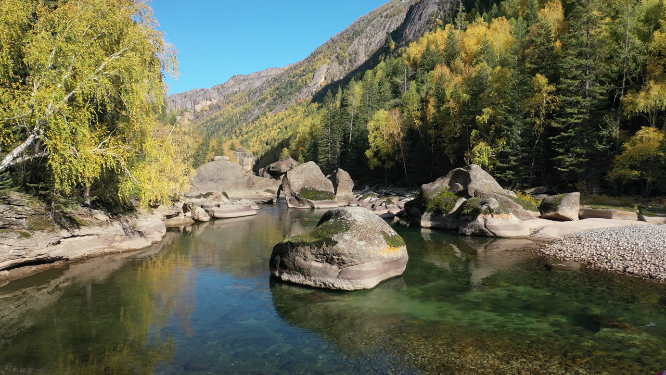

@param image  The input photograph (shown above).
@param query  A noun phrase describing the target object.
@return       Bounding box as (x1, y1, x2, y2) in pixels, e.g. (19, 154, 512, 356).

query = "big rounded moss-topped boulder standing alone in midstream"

(270, 207, 408, 290)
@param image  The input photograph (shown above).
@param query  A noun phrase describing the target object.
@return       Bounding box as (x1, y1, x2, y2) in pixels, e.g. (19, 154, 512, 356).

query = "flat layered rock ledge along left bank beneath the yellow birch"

(0, 193, 166, 282)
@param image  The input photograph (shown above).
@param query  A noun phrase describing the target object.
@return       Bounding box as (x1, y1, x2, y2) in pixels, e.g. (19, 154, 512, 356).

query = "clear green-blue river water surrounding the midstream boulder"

(0, 205, 666, 374)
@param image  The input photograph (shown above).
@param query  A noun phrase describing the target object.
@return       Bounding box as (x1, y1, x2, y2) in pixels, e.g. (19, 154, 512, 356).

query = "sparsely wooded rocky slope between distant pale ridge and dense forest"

(182, 0, 462, 164)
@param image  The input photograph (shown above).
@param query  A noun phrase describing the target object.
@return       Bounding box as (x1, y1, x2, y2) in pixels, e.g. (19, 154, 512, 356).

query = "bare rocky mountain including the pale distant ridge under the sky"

(168, 0, 458, 166)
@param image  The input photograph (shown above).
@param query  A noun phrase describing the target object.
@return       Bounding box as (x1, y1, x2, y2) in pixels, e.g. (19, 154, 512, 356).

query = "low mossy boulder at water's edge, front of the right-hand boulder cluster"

(458, 198, 531, 238)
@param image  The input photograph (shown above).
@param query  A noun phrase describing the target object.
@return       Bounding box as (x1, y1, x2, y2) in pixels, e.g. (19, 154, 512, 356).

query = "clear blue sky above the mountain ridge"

(150, 0, 388, 94)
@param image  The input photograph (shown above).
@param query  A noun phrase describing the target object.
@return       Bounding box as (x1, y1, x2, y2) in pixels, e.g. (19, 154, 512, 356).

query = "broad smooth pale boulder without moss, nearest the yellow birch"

(188, 160, 280, 199)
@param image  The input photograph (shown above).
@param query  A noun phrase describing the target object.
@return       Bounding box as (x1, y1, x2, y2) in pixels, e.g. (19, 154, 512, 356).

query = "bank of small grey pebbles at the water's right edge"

(541, 225, 666, 280)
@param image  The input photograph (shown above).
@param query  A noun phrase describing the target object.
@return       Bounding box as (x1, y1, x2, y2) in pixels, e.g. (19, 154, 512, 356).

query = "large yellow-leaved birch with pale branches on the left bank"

(0, 0, 190, 203)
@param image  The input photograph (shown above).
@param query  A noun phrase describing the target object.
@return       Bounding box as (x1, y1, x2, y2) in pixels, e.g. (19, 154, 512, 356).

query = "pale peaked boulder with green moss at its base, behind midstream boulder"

(281, 161, 339, 208)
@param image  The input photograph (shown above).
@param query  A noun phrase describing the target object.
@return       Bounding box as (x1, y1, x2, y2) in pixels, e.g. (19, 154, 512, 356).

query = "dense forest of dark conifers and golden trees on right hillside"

(206, 0, 666, 198)
